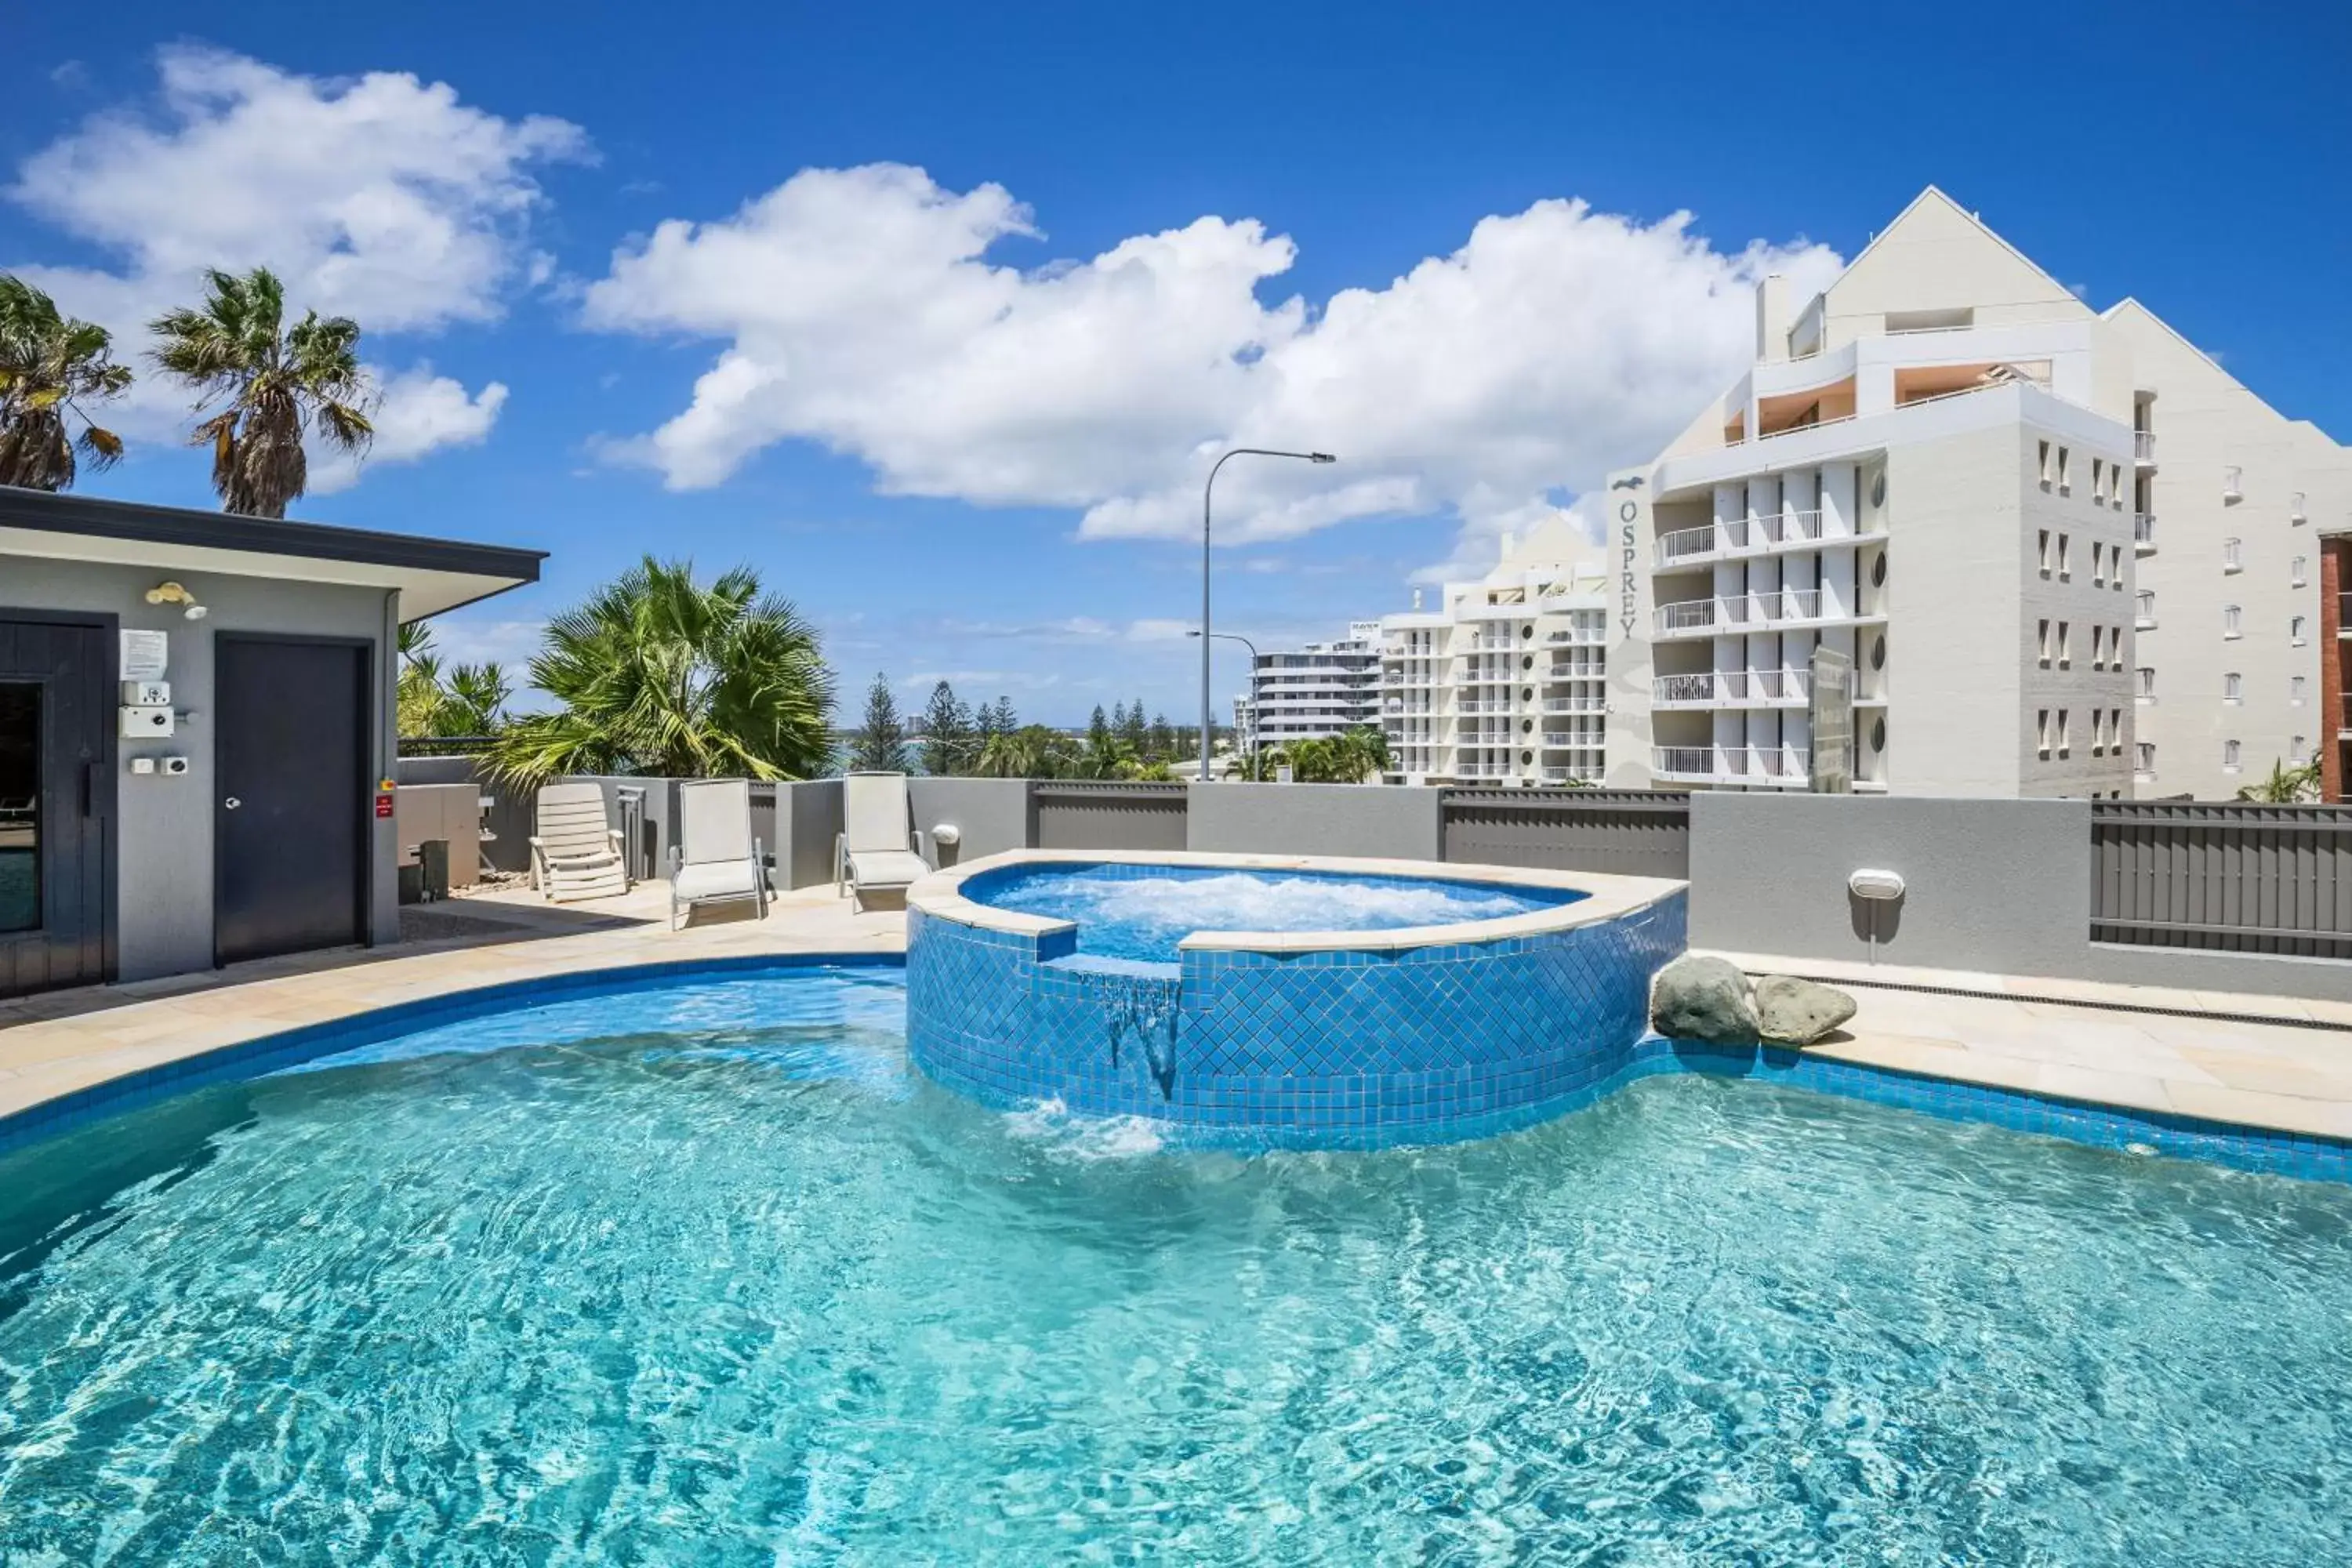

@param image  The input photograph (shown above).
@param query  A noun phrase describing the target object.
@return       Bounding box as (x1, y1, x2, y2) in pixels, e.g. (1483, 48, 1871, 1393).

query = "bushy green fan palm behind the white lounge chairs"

(487, 555, 833, 787)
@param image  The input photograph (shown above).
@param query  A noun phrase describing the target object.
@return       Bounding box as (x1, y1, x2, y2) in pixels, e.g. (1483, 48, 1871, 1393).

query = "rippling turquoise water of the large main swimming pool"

(0, 971, 2352, 1568)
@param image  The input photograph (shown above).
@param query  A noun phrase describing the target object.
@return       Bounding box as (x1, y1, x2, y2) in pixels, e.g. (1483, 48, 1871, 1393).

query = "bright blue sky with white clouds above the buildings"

(0, 0, 2352, 722)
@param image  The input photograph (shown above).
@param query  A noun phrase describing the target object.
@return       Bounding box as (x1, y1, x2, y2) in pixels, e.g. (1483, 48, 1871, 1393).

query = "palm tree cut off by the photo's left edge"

(0, 273, 132, 492)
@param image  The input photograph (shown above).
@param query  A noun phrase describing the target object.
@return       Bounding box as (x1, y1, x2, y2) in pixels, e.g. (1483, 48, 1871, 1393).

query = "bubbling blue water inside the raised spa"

(964, 865, 1583, 964)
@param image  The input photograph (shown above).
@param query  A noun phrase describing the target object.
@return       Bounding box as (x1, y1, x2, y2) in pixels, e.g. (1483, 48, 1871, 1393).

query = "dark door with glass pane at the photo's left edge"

(0, 609, 115, 996)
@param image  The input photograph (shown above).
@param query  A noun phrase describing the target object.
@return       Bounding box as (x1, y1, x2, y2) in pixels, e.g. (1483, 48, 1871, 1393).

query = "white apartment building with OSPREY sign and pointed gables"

(1606, 188, 2352, 797)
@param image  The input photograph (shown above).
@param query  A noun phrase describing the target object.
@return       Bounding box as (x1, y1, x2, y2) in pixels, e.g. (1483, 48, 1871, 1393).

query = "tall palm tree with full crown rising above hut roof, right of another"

(148, 268, 376, 517)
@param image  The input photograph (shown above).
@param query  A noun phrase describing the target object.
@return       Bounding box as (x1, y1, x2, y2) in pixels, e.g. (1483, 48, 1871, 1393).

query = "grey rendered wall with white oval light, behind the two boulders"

(1691, 789, 2352, 1001)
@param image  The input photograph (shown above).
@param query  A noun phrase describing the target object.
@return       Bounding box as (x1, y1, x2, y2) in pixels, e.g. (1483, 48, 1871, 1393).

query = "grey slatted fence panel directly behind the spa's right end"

(1437, 789, 1691, 879)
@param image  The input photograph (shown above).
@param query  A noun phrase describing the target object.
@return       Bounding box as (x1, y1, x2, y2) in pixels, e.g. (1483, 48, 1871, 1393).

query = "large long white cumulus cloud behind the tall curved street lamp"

(586, 165, 1837, 566)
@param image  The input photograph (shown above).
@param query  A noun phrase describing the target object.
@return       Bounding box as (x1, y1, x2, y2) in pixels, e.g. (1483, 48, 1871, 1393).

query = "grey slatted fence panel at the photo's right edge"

(2091, 801, 2352, 959)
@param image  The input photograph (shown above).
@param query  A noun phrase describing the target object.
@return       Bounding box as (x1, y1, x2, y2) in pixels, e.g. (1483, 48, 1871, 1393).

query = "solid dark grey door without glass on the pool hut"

(212, 633, 374, 964)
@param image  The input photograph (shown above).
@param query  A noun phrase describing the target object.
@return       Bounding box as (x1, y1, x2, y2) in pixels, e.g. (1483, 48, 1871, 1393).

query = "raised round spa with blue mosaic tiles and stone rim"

(908, 851, 1684, 1147)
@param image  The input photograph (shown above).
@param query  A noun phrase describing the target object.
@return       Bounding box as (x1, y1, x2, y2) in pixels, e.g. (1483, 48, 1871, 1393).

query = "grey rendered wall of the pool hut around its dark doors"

(0, 555, 400, 980)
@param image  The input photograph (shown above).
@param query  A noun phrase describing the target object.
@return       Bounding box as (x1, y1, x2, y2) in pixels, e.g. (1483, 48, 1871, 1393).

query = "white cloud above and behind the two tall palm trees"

(0, 45, 590, 492)
